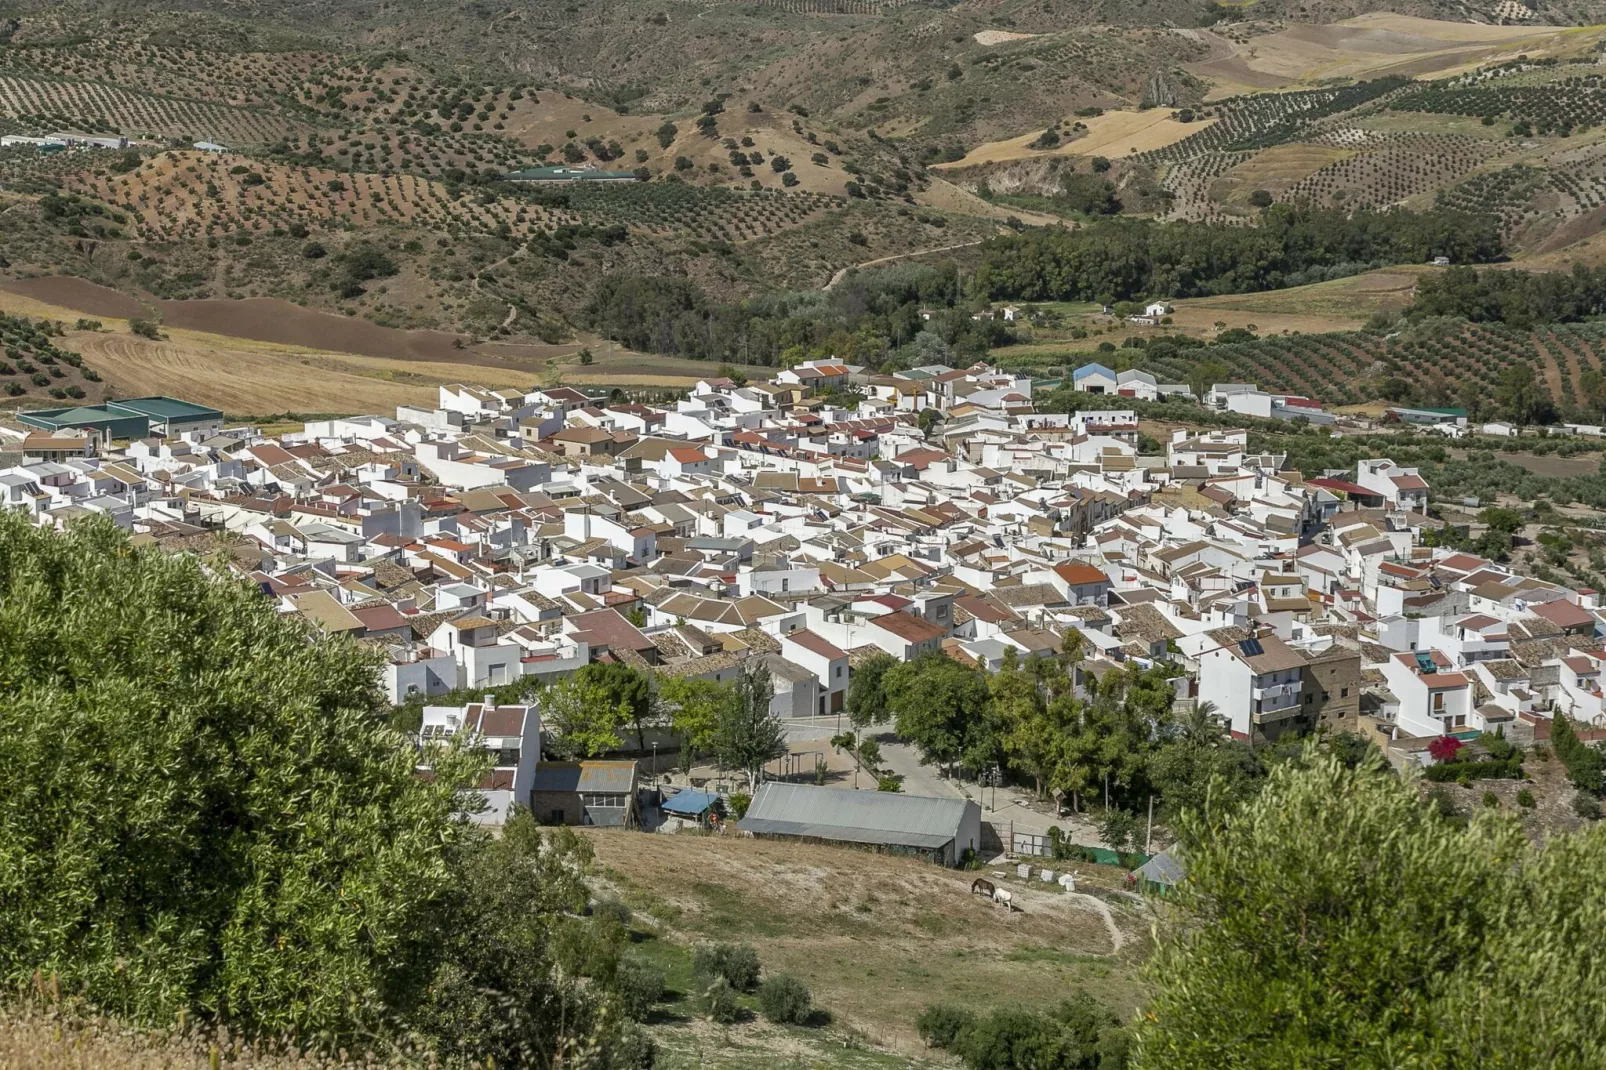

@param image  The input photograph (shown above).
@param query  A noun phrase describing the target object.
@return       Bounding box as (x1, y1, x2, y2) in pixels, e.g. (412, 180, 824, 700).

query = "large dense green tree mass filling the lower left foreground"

(0, 513, 641, 1067)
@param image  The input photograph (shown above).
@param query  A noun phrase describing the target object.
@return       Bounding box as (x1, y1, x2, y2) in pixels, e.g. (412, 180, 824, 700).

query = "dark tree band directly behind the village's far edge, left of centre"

(586, 265, 1013, 366)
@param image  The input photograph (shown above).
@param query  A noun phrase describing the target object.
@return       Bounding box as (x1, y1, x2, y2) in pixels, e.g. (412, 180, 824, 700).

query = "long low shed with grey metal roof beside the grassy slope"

(740, 781, 981, 866)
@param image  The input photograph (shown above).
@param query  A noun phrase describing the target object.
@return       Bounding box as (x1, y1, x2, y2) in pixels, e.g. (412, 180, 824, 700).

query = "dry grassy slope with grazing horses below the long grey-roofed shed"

(589, 831, 1148, 1047)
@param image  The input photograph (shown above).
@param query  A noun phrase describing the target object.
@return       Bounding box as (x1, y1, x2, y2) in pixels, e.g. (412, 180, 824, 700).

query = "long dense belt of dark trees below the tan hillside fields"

(976, 204, 1502, 300)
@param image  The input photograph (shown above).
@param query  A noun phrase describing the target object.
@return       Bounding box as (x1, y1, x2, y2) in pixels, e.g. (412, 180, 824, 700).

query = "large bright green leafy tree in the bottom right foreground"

(1135, 749, 1606, 1070)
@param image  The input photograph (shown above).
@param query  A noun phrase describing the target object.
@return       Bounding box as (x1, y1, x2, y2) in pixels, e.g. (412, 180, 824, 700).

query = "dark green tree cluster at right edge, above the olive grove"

(1410, 263, 1606, 328)
